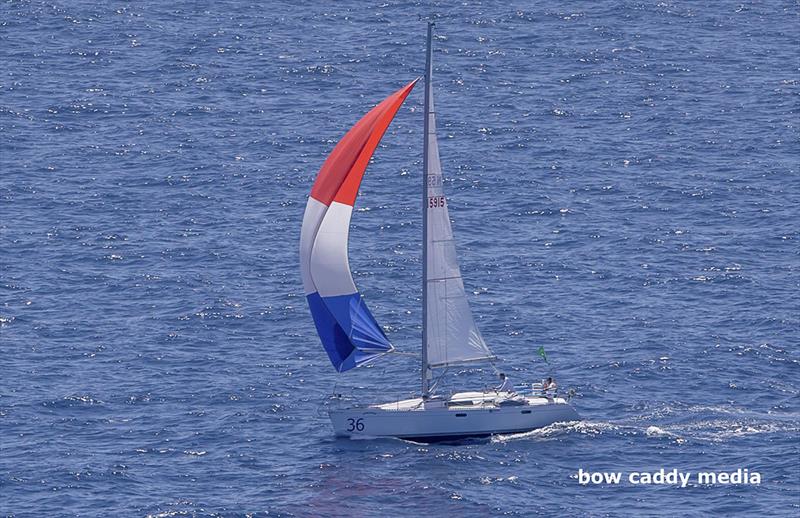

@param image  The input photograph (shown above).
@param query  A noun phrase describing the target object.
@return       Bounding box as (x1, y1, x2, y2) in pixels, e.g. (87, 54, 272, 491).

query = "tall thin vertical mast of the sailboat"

(422, 22, 433, 399)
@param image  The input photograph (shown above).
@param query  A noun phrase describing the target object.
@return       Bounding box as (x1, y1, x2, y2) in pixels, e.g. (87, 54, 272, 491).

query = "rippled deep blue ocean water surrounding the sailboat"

(0, 0, 800, 516)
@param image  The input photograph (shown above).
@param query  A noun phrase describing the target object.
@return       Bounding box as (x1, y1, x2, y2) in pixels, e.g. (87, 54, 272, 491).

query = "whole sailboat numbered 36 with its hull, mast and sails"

(300, 23, 579, 442)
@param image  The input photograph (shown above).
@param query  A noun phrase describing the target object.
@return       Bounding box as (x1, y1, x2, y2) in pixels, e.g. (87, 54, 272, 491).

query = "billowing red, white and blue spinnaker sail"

(300, 80, 416, 372)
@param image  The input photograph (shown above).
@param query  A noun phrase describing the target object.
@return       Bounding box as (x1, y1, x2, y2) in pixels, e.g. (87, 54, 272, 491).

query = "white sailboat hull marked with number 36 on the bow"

(329, 393, 580, 442)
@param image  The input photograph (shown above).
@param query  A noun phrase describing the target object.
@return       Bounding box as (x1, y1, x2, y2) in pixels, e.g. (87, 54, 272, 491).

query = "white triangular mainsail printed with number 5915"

(423, 51, 494, 375)
